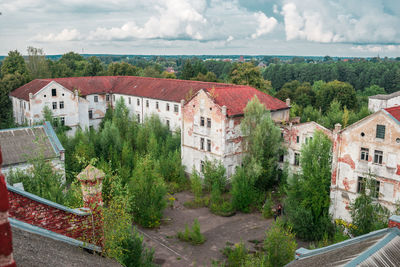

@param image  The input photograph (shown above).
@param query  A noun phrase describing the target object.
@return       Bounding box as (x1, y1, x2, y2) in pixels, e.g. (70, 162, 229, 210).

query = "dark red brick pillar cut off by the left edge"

(0, 148, 16, 267)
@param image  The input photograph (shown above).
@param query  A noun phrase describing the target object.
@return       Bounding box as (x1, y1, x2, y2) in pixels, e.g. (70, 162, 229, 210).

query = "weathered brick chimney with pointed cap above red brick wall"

(77, 165, 105, 209)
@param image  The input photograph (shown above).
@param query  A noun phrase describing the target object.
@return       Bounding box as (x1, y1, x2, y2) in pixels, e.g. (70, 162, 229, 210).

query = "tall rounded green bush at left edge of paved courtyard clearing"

(129, 156, 167, 227)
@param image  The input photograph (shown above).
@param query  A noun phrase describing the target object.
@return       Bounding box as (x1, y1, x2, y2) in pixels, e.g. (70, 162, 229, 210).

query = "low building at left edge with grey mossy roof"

(0, 122, 65, 181)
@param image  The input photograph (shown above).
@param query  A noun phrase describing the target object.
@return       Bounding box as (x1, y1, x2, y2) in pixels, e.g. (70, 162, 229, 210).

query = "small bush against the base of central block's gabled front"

(203, 160, 227, 192)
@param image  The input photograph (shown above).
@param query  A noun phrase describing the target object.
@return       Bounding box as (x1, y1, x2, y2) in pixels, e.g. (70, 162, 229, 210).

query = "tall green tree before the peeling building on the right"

(285, 131, 333, 240)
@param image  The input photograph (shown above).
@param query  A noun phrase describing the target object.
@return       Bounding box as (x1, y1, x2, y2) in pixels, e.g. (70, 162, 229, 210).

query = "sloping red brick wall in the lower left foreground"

(8, 191, 102, 246)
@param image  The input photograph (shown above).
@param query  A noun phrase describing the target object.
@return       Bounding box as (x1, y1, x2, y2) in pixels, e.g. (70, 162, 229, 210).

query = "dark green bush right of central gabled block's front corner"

(231, 167, 255, 212)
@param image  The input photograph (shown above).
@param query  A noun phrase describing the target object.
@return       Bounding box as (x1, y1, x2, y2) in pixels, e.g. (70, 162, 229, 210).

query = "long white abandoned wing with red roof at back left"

(10, 76, 250, 135)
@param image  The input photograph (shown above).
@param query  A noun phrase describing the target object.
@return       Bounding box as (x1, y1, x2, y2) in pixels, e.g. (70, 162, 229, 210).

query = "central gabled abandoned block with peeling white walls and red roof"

(181, 86, 290, 178)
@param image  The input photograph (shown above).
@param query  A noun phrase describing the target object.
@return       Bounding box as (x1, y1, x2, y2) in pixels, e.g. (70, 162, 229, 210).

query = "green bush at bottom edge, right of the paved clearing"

(264, 220, 297, 266)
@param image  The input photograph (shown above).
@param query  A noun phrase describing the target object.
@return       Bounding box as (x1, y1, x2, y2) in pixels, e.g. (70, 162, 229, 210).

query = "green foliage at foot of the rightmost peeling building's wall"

(350, 173, 390, 236)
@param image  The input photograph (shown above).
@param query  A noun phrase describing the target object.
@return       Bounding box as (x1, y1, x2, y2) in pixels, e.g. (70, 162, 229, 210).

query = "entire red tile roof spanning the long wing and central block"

(10, 76, 288, 116)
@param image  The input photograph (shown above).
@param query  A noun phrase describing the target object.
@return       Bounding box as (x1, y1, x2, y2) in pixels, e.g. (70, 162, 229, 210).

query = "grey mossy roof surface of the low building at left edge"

(0, 126, 57, 166)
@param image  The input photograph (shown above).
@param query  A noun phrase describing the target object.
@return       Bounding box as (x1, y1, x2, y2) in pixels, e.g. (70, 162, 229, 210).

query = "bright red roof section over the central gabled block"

(208, 85, 289, 116)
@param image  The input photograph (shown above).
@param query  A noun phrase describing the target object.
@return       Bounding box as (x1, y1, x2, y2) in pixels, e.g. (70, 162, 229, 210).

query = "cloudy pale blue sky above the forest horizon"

(0, 0, 400, 57)
